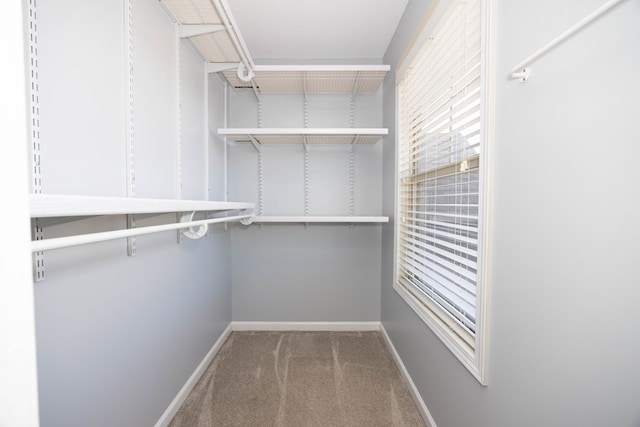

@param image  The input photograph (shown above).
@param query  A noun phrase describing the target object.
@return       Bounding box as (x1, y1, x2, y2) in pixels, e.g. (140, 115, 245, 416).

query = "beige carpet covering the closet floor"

(170, 332, 425, 427)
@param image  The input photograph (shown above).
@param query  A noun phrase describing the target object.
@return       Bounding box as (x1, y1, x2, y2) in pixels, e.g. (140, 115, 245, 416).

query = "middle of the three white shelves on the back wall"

(218, 128, 389, 145)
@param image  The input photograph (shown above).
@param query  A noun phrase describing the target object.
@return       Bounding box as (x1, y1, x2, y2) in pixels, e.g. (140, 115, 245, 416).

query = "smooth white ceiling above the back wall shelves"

(227, 0, 408, 61)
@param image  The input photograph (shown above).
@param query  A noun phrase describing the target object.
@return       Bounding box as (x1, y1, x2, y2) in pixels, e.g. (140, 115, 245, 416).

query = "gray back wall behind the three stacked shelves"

(229, 87, 382, 322)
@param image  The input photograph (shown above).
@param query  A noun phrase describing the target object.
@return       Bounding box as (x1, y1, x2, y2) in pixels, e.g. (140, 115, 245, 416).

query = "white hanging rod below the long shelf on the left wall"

(31, 214, 254, 252)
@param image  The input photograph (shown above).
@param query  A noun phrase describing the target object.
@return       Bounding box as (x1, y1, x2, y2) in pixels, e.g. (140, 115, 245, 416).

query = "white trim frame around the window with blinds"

(393, 0, 495, 386)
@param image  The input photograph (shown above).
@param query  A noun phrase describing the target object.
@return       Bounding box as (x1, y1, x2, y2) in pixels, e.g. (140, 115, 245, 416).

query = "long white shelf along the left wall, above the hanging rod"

(29, 194, 255, 218)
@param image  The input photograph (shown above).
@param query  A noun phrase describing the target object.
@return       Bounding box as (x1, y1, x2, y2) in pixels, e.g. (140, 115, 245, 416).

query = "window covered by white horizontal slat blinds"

(395, 0, 489, 384)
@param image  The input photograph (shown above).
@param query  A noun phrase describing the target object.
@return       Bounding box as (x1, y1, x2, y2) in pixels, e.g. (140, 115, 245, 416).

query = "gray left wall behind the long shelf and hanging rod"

(34, 0, 231, 427)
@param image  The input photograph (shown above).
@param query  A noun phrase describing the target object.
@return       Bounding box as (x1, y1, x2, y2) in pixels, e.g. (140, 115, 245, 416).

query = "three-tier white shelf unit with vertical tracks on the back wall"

(218, 65, 390, 226)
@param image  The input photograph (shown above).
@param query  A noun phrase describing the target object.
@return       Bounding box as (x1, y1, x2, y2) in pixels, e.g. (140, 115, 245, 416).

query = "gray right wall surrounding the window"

(382, 0, 640, 427)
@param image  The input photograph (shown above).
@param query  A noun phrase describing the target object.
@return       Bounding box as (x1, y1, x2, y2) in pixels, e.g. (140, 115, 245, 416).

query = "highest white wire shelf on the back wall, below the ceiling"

(223, 65, 390, 95)
